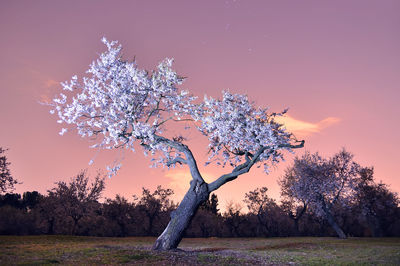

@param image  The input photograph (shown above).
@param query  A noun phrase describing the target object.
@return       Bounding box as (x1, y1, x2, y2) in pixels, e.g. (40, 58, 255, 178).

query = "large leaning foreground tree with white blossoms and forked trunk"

(50, 38, 304, 250)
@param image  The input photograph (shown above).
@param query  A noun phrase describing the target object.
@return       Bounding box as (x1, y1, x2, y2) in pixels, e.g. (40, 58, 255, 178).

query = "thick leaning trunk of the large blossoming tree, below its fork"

(153, 180, 210, 250)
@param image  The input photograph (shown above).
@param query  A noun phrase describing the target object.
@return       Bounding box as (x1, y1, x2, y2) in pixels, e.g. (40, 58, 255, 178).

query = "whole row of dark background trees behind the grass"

(0, 150, 400, 237)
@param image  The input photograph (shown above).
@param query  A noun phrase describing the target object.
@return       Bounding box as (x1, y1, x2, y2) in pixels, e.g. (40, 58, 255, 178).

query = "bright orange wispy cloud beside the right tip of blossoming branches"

(276, 115, 340, 137)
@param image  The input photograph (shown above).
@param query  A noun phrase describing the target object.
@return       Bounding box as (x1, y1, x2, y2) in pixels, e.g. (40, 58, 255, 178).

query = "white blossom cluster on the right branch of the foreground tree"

(198, 91, 292, 172)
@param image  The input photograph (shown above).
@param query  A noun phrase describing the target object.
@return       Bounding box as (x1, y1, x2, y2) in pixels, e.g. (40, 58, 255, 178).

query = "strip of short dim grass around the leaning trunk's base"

(0, 236, 400, 265)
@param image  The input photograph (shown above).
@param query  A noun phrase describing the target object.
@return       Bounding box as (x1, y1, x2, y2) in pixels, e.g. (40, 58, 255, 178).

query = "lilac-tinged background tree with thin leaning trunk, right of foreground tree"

(280, 149, 359, 238)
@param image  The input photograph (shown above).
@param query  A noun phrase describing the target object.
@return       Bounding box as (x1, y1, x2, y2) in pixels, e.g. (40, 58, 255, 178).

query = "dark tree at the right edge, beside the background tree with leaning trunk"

(355, 167, 400, 237)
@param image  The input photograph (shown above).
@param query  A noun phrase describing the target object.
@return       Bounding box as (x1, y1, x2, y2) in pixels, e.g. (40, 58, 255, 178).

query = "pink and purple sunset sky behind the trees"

(0, 0, 400, 211)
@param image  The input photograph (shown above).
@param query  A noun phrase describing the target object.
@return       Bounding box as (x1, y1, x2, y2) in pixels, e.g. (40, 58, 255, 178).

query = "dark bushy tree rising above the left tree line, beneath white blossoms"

(48, 171, 105, 234)
